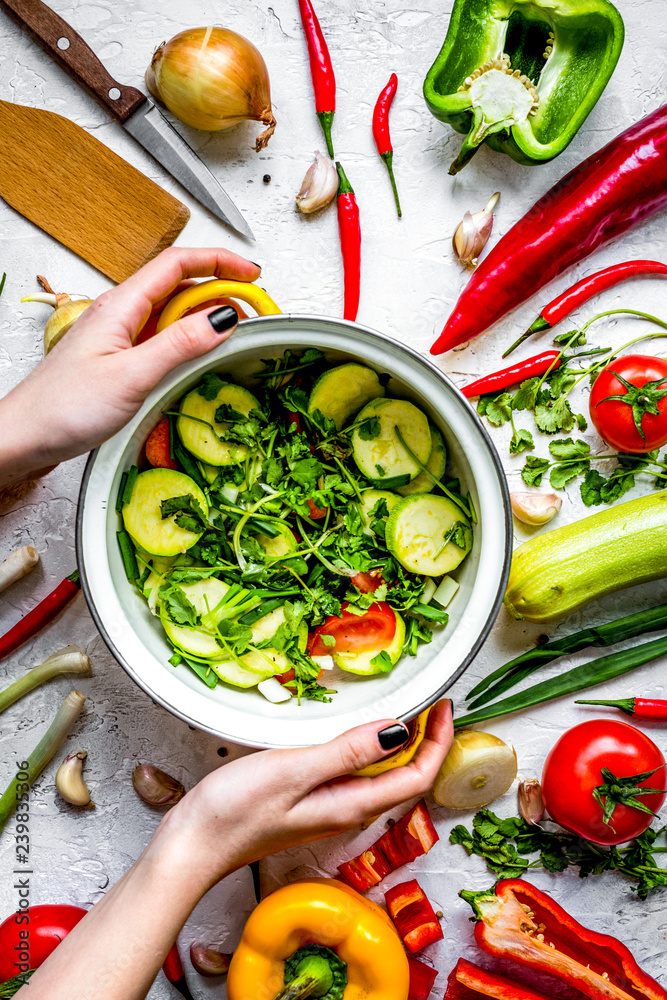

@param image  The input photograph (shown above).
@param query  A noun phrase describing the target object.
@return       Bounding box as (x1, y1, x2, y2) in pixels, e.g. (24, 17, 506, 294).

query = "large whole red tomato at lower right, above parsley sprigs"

(542, 719, 665, 844)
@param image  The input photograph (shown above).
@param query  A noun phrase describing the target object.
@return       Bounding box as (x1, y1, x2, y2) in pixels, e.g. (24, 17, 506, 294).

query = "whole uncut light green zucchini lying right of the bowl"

(505, 490, 667, 622)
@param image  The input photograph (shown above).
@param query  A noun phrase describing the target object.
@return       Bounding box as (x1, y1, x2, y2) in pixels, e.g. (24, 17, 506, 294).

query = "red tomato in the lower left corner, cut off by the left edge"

(0, 904, 87, 983)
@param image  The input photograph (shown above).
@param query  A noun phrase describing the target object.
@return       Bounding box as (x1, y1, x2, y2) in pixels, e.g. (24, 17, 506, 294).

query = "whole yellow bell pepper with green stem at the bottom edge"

(227, 879, 410, 1000)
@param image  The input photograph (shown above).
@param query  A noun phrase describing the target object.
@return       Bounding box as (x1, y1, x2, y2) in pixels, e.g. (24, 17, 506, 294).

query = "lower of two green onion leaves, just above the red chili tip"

(454, 636, 667, 729)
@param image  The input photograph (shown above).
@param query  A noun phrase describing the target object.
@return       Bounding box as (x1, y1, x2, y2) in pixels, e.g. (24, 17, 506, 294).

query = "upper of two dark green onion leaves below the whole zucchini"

(467, 604, 667, 709)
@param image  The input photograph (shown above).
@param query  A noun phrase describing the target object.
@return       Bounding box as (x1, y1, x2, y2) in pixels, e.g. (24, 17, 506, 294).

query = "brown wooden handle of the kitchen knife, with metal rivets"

(0, 0, 146, 122)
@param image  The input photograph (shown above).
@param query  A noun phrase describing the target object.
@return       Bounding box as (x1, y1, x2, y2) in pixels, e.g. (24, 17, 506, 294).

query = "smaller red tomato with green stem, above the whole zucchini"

(589, 354, 667, 453)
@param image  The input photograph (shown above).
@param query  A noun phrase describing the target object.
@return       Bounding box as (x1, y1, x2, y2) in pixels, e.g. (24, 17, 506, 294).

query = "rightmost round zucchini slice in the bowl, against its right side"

(386, 493, 472, 576)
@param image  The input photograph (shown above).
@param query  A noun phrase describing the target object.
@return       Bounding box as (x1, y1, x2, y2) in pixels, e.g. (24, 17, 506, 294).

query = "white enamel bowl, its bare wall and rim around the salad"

(77, 315, 512, 747)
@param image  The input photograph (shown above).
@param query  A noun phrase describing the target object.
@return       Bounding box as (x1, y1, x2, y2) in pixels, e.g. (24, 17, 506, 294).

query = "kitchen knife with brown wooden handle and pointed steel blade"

(0, 0, 255, 240)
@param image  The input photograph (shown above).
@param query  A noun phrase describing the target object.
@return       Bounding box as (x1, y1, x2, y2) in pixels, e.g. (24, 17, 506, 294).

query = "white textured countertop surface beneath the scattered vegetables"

(0, 0, 667, 1000)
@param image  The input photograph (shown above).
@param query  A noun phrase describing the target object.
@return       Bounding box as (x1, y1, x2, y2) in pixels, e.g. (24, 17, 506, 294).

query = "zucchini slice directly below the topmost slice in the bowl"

(352, 399, 431, 480)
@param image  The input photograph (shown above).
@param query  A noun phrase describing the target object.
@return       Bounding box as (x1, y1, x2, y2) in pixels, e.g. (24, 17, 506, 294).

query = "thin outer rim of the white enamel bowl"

(75, 312, 513, 749)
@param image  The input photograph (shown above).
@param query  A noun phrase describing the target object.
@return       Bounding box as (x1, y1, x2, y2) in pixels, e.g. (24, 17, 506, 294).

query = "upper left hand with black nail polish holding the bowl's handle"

(0, 247, 260, 486)
